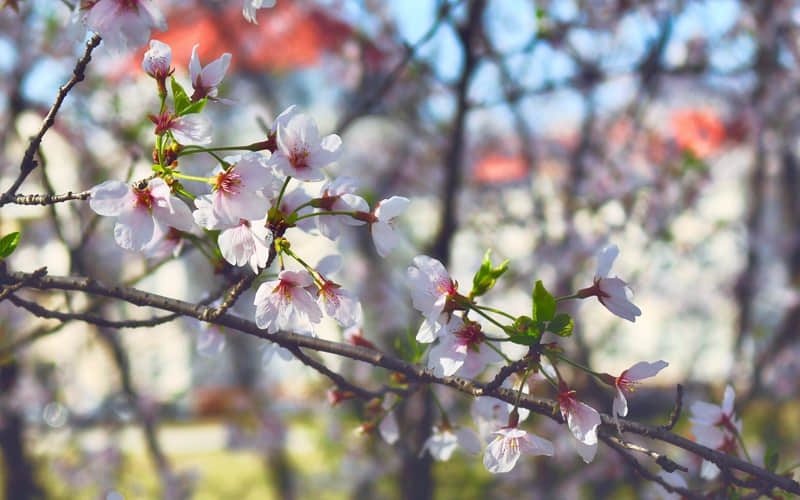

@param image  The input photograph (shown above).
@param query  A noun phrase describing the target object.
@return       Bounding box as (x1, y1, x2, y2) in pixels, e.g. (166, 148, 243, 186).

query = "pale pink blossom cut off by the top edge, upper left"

(81, 0, 167, 50)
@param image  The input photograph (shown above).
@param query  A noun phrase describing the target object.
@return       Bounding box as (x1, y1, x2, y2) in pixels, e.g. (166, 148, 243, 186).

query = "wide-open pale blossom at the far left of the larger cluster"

(89, 178, 194, 251)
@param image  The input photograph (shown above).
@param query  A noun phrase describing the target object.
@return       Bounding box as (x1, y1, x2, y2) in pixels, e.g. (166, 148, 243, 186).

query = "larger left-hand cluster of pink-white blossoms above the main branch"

(89, 40, 409, 332)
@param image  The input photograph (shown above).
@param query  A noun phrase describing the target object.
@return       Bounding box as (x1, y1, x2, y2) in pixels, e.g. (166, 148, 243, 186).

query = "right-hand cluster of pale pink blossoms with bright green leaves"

(408, 250, 667, 473)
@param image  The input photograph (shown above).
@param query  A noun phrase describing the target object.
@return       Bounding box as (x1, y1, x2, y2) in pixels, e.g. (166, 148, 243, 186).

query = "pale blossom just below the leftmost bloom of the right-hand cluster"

(428, 316, 502, 378)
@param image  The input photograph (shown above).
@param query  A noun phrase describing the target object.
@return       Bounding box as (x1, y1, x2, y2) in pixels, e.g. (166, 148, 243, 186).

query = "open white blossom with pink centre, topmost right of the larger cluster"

(272, 111, 342, 181)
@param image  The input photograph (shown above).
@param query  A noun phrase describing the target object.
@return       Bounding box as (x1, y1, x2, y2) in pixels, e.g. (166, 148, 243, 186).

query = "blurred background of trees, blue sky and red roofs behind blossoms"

(0, 0, 800, 500)
